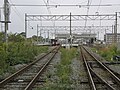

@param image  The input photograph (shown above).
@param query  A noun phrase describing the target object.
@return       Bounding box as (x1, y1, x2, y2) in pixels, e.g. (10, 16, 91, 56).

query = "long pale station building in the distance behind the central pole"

(55, 33, 96, 43)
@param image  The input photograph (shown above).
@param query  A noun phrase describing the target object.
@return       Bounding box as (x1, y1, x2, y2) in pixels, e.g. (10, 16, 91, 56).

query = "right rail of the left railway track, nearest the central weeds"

(24, 47, 60, 90)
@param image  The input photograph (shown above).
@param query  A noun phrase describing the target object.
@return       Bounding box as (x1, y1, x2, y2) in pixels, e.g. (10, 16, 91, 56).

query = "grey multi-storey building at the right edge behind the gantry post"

(104, 33, 120, 44)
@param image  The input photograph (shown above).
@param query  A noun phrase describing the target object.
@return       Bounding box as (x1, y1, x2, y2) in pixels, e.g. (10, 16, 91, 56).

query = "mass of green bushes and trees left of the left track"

(0, 32, 48, 74)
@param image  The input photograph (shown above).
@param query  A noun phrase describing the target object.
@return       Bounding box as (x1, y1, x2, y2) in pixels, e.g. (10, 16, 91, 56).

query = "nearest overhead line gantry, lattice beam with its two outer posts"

(25, 13, 117, 42)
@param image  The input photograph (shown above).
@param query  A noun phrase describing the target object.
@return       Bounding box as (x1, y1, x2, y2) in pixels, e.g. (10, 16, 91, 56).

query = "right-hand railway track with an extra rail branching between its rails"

(80, 46, 120, 90)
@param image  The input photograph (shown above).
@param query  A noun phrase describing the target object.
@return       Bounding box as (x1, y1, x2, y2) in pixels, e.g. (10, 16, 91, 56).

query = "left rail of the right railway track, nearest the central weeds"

(81, 48, 97, 90)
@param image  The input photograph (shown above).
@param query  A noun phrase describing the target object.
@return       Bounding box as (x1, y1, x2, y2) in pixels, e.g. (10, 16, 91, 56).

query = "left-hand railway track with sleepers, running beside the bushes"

(0, 46, 60, 90)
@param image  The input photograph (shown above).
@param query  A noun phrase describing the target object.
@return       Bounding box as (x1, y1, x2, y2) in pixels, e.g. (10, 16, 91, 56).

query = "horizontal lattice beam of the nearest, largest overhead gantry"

(26, 14, 116, 21)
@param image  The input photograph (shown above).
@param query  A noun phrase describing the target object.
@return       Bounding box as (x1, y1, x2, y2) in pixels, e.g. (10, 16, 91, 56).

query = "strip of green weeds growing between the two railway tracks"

(37, 48, 77, 90)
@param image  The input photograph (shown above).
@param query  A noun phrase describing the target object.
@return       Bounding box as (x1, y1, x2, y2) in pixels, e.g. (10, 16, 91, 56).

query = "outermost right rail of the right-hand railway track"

(83, 47, 120, 86)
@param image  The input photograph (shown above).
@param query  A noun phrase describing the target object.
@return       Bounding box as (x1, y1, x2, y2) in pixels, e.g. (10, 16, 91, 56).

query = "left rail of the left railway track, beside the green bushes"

(0, 47, 57, 87)
